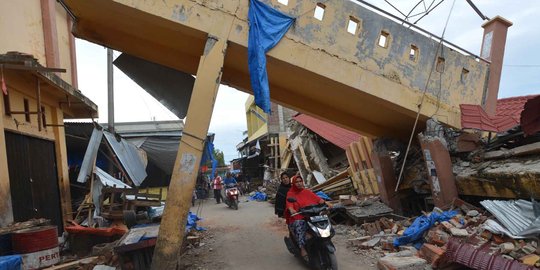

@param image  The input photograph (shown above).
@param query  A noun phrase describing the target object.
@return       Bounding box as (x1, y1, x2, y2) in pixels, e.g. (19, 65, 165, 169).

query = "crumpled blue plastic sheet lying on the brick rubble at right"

(394, 211, 458, 249)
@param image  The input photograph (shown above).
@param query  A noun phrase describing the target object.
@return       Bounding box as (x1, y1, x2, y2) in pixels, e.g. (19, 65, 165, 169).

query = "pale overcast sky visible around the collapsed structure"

(76, 0, 540, 162)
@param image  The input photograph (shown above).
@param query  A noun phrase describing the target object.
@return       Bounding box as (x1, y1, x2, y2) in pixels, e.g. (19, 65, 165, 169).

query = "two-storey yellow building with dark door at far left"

(0, 0, 97, 227)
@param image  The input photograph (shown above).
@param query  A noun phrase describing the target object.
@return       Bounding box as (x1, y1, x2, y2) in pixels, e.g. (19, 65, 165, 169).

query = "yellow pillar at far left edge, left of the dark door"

(0, 91, 13, 227)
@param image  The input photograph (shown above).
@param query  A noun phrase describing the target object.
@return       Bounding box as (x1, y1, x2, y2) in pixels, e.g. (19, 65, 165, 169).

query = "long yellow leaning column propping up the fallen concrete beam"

(152, 36, 227, 270)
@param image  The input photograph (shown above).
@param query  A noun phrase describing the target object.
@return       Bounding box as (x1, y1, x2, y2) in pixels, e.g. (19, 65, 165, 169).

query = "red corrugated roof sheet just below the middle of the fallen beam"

(294, 114, 361, 149)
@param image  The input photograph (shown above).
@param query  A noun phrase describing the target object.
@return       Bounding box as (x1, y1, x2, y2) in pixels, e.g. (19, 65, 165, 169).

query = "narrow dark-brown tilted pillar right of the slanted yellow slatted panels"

(371, 140, 403, 214)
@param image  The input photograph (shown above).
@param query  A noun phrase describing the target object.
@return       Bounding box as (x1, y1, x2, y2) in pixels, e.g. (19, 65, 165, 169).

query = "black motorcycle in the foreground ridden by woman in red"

(284, 198, 338, 270)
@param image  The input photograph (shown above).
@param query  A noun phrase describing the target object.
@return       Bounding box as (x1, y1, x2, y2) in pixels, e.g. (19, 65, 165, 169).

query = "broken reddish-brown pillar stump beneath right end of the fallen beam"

(419, 135, 458, 207)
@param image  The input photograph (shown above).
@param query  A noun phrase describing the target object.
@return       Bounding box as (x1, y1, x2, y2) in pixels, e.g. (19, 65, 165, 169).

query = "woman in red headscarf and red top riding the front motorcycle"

(285, 175, 331, 259)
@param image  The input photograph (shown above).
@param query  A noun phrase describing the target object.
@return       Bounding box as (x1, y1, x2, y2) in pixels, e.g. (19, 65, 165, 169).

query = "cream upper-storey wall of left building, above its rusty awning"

(0, 0, 72, 84)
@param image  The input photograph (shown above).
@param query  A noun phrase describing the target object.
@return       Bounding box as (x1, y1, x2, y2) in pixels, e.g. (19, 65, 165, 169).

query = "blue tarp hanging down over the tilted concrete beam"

(248, 0, 295, 113)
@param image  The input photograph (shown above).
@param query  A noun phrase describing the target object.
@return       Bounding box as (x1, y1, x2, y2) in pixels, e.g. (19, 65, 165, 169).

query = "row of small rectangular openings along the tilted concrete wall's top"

(278, 0, 469, 82)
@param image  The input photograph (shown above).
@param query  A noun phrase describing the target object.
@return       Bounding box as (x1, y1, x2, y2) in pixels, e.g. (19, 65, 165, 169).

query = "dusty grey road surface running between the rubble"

(180, 198, 375, 270)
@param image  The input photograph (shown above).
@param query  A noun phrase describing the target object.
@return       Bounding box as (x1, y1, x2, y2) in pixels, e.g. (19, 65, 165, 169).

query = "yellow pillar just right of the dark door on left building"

(48, 108, 73, 227)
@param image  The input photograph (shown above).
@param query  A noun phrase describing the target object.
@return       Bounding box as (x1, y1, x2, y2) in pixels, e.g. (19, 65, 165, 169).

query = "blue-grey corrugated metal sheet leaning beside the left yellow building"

(103, 131, 147, 186)
